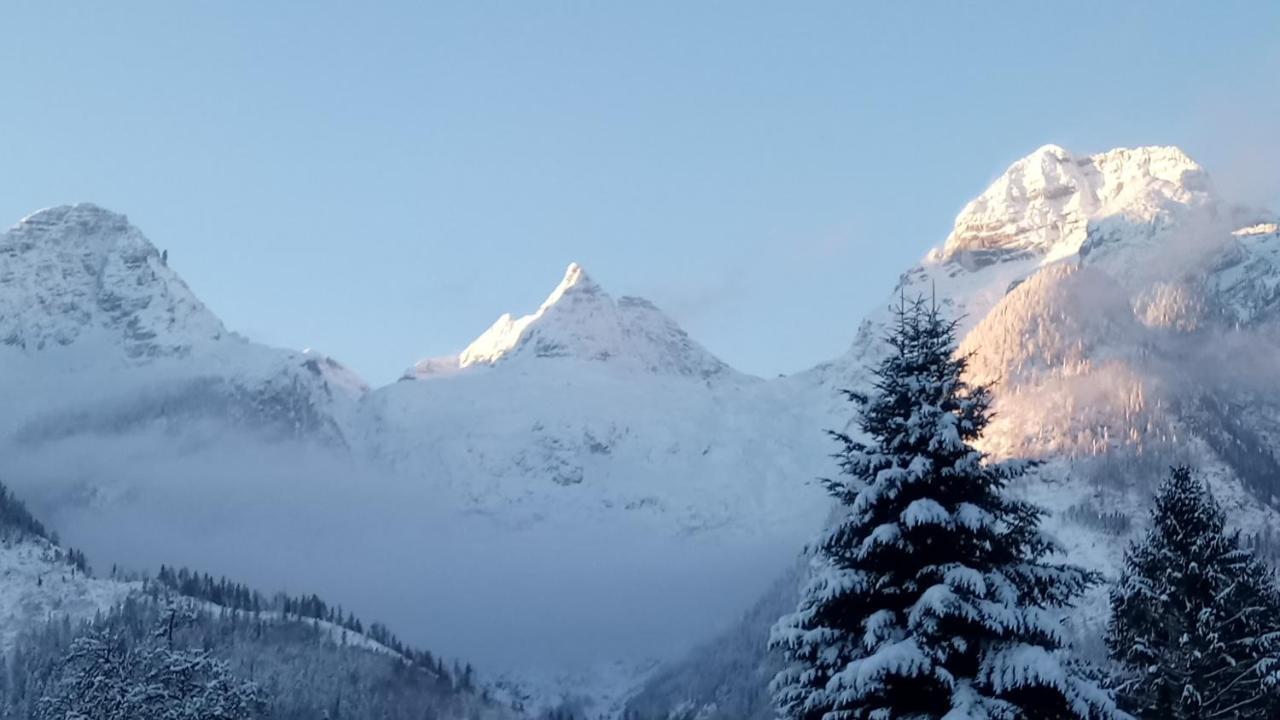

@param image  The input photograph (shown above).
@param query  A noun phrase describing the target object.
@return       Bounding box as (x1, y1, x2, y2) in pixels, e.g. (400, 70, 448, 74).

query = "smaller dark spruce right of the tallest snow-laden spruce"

(1107, 468, 1280, 720)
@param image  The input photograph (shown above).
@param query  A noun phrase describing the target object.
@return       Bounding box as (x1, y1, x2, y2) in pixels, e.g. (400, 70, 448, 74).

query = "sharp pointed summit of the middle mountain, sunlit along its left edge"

(406, 263, 732, 378)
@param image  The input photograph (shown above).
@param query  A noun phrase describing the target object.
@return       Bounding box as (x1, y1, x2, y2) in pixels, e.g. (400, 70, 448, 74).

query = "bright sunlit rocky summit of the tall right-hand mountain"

(936, 145, 1220, 266)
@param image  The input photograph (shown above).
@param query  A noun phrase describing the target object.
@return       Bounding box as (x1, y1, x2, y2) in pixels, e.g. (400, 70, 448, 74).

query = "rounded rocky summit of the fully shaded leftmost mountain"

(0, 204, 227, 359)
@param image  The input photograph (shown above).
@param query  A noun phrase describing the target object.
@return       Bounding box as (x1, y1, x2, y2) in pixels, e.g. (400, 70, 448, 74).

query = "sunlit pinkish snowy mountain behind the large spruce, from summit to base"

(631, 146, 1280, 720)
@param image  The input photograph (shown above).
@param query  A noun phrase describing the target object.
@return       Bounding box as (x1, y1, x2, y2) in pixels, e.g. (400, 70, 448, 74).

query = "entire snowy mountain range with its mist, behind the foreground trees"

(0, 146, 1280, 720)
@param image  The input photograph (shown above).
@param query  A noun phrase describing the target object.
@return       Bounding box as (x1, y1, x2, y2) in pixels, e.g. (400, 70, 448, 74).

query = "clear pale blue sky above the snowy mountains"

(0, 0, 1280, 383)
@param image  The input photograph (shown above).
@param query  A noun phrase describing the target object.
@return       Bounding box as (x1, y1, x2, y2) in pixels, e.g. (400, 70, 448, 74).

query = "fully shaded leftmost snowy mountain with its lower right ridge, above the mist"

(0, 204, 365, 443)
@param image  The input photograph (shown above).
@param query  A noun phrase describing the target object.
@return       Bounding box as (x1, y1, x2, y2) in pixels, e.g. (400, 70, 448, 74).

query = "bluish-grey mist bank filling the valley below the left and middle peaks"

(0, 433, 799, 676)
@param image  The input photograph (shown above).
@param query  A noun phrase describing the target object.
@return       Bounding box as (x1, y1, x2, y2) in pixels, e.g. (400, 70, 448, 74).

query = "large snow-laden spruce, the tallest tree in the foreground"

(771, 294, 1124, 720)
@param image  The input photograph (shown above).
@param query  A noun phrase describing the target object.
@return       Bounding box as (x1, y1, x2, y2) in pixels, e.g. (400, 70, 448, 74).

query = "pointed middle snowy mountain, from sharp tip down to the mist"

(371, 264, 824, 541)
